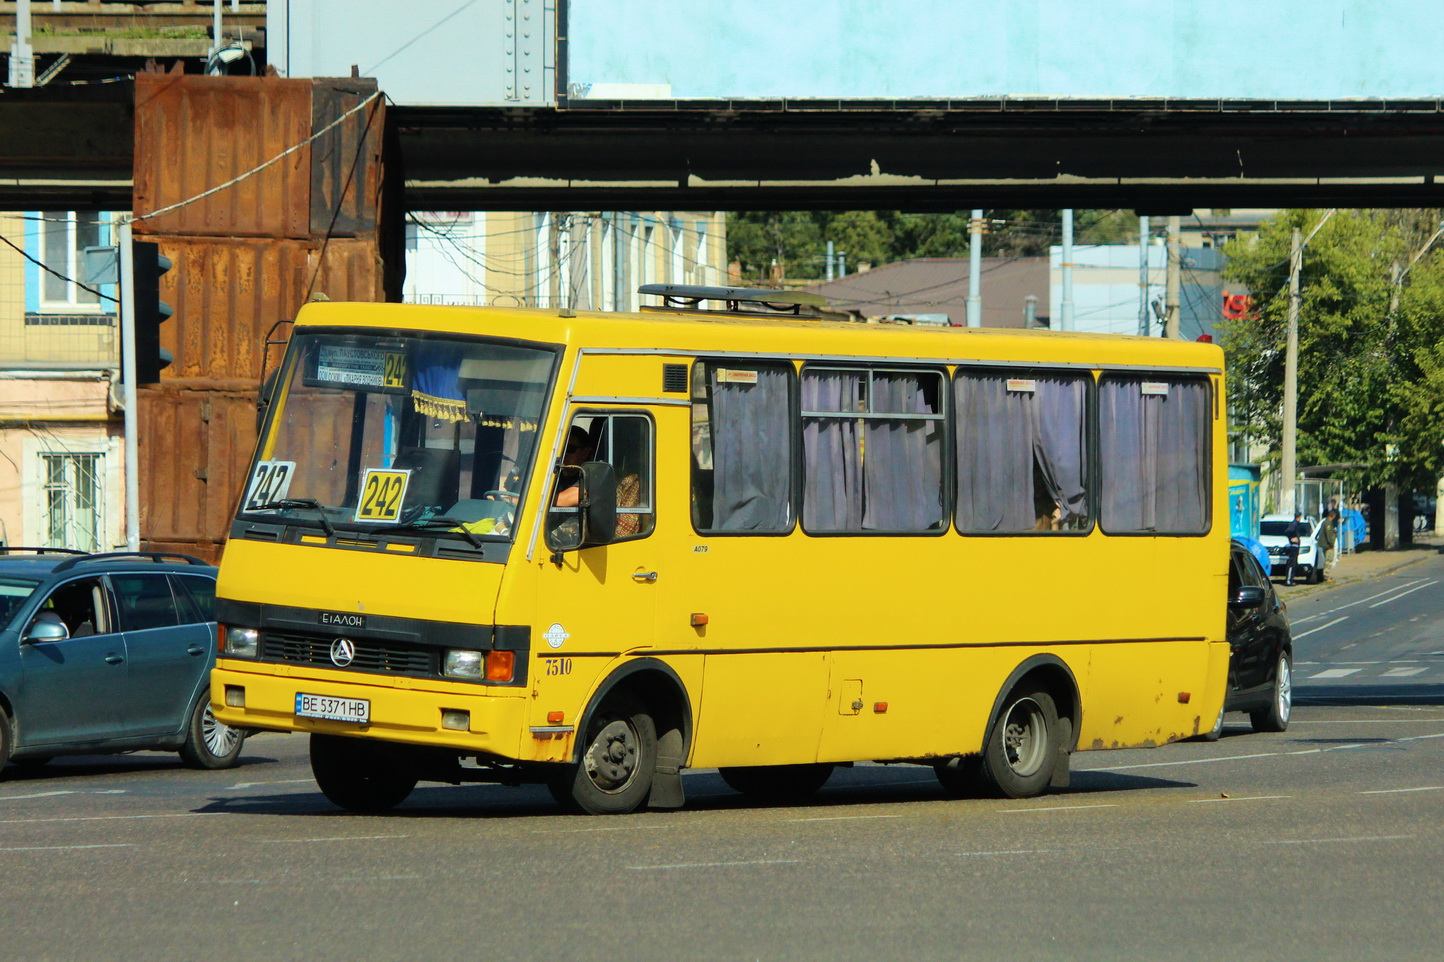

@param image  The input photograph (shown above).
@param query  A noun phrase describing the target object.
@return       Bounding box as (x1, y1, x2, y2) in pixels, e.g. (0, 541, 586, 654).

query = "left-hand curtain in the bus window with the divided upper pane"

(803, 371, 866, 532)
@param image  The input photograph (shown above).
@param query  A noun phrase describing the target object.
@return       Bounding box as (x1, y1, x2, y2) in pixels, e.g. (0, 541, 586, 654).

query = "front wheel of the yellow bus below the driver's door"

(547, 695, 657, 815)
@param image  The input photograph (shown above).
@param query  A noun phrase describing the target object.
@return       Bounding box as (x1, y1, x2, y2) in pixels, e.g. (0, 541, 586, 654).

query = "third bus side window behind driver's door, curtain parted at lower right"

(954, 371, 1092, 533)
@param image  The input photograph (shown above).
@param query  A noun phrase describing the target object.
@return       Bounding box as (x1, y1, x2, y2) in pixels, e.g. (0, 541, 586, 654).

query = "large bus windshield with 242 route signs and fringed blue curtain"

(240, 332, 556, 545)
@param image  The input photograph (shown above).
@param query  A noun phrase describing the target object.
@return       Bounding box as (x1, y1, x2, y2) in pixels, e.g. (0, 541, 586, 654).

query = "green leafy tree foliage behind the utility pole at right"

(1222, 209, 1444, 487)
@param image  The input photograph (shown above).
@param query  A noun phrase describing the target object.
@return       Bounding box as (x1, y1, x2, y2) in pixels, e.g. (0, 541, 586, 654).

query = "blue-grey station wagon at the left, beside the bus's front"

(0, 547, 244, 768)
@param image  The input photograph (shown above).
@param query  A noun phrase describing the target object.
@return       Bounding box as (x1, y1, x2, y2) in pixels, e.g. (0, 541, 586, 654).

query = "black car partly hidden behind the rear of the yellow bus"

(1204, 542, 1294, 741)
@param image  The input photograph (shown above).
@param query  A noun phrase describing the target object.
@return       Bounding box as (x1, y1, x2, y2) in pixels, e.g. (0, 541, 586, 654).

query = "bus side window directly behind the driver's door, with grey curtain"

(692, 361, 793, 534)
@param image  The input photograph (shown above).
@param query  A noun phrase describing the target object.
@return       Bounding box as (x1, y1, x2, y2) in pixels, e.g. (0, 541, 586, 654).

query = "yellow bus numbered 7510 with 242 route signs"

(211, 287, 1229, 813)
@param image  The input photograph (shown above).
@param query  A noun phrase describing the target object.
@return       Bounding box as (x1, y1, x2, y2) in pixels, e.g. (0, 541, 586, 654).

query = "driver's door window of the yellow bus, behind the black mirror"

(547, 413, 656, 547)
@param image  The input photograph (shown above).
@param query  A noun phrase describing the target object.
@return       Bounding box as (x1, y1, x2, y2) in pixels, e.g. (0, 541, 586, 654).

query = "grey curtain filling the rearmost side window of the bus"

(1099, 380, 1210, 533)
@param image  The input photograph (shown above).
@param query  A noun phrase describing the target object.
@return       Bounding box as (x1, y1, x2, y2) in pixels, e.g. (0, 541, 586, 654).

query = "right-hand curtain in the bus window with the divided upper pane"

(862, 374, 943, 532)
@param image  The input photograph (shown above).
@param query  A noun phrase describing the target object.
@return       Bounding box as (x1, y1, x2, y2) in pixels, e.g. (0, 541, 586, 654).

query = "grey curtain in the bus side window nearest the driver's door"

(709, 365, 793, 532)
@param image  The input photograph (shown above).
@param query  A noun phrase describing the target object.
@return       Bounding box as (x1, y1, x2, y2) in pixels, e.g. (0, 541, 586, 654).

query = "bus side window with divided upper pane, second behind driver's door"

(801, 365, 947, 533)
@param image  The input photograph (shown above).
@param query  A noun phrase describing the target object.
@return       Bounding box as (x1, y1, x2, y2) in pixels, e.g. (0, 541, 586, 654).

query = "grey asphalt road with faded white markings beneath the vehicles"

(0, 558, 1444, 962)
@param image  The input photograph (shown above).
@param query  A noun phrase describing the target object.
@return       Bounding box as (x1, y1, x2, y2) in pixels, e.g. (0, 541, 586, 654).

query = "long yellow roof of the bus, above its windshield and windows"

(296, 302, 1223, 371)
